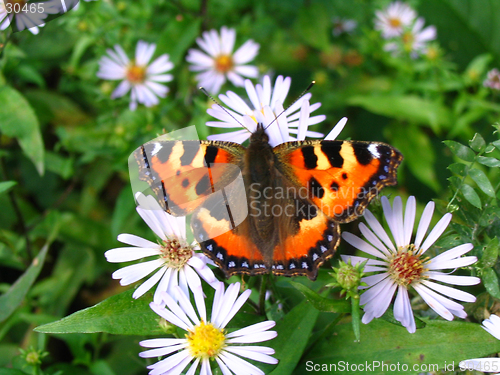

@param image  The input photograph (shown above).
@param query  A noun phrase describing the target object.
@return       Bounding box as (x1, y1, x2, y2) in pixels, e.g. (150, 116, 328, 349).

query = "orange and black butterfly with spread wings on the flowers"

(134, 124, 403, 280)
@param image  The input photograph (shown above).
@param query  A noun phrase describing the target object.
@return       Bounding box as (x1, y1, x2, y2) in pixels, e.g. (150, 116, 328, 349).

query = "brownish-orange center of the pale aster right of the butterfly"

(389, 245, 429, 287)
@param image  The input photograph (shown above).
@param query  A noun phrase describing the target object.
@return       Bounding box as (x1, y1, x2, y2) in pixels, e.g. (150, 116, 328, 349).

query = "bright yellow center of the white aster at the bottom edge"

(186, 320, 226, 359)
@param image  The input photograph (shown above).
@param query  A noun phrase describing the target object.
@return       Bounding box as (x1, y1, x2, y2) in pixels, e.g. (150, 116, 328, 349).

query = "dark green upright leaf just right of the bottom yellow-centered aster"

(265, 301, 320, 375)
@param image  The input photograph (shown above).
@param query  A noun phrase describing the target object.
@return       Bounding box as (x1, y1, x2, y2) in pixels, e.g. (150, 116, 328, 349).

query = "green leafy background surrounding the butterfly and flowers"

(0, 0, 500, 375)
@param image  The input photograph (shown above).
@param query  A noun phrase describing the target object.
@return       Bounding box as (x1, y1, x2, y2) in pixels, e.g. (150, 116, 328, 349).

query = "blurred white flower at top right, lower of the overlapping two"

(384, 18, 437, 59)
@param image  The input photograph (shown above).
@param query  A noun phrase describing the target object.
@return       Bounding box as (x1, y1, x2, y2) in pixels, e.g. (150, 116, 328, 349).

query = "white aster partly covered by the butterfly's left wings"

(104, 193, 218, 303)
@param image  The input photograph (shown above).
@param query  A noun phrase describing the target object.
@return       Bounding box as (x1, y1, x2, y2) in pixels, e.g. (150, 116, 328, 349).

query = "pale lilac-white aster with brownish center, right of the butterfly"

(342, 197, 481, 333)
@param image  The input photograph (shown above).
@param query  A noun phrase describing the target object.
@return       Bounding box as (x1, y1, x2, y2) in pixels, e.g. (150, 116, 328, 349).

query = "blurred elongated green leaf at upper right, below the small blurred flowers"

(347, 95, 451, 133)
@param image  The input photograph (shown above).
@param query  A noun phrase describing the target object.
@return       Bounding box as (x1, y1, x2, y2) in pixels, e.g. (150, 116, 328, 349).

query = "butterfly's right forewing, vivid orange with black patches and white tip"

(274, 141, 403, 223)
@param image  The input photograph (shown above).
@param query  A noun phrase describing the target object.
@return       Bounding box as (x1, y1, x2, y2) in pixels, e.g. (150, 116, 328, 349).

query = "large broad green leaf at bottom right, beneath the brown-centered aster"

(293, 319, 500, 375)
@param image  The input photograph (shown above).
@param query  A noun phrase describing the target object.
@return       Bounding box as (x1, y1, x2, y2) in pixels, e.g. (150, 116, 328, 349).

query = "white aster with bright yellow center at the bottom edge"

(139, 282, 278, 375)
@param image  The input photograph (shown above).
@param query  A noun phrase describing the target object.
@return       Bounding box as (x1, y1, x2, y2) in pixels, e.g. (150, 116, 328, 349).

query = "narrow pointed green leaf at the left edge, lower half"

(0, 244, 49, 322)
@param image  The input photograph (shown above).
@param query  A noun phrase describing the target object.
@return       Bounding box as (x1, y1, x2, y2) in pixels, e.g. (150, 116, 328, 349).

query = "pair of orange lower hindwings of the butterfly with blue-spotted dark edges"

(191, 184, 340, 280)
